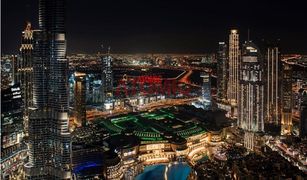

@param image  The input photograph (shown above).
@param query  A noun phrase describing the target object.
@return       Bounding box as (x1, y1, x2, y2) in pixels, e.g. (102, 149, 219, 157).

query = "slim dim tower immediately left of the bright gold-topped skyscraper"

(217, 42, 228, 100)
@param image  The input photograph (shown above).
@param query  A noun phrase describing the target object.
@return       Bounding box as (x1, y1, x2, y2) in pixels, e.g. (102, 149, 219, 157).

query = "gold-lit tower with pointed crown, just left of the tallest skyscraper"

(16, 22, 35, 130)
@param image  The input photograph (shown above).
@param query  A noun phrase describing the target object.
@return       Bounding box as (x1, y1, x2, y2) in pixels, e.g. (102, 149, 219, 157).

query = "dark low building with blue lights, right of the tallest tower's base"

(71, 125, 109, 179)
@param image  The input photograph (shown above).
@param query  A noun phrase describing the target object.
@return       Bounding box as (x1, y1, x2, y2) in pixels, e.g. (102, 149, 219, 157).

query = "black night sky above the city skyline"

(1, 0, 307, 54)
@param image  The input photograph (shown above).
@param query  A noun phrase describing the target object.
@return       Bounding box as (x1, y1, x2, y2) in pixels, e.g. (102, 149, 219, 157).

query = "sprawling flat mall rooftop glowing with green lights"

(94, 107, 206, 142)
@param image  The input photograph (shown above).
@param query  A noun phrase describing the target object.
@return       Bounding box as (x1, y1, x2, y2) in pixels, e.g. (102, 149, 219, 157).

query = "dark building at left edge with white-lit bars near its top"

(0, 84, 27, 179)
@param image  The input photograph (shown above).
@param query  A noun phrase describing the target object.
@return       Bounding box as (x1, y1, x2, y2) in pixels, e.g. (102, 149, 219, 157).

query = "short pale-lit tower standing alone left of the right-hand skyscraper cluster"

(200, 73, 212, 110)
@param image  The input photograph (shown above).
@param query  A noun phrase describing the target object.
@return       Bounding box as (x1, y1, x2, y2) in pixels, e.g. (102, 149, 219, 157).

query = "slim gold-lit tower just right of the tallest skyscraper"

(74, 72, 86, 126)
